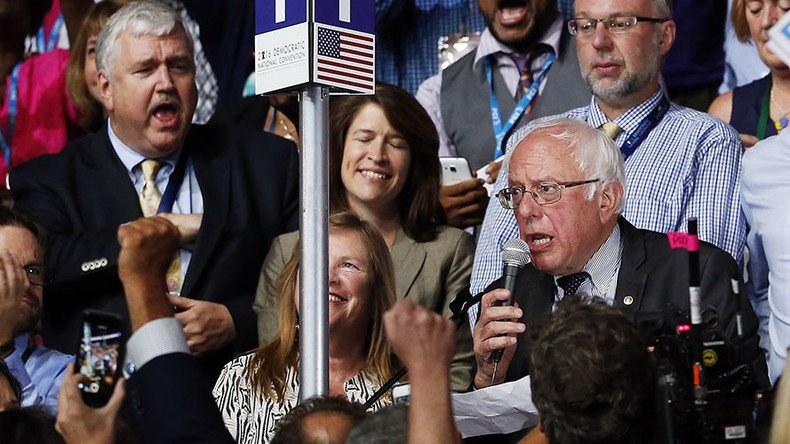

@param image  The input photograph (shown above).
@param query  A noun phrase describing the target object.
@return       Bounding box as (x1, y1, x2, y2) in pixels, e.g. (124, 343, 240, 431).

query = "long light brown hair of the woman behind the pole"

(246, 212, 395, 402)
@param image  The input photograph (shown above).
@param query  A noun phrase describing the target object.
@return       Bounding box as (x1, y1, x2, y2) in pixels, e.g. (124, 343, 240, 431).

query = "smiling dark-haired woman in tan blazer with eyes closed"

(254, 83, 474, 391)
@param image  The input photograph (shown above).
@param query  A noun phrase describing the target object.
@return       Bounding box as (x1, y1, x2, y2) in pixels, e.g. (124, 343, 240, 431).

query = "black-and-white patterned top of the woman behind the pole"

(212, 353, 391, 444)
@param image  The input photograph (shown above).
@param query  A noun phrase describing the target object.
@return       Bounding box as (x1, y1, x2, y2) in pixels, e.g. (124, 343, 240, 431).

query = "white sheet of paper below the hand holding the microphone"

(452, 376, 538, 438)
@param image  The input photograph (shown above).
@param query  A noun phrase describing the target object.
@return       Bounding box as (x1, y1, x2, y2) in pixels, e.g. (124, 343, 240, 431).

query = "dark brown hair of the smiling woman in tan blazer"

(329, 83, 446, 242)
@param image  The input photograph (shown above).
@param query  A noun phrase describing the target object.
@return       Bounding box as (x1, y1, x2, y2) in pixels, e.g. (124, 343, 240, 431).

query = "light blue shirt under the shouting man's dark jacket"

(107, 119, 203, 276)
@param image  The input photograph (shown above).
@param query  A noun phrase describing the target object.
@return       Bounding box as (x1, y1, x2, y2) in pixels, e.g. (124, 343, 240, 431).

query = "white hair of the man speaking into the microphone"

(514, 117, 626, 214)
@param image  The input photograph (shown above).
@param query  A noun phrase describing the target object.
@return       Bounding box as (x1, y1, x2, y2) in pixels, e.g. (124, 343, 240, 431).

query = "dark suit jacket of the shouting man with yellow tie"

(10, 125, 299, 372)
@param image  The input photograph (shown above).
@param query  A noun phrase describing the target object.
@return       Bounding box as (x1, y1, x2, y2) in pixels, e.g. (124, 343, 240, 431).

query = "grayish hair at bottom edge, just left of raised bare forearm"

(346, 404, 409, 444)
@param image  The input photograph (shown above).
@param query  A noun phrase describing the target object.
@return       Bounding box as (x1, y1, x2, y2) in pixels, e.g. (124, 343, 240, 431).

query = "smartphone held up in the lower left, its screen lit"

(74, 310, 126, 407)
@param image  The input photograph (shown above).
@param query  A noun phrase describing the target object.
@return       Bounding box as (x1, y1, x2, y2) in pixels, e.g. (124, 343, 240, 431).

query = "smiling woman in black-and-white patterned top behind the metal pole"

(213, 213, 395, 443)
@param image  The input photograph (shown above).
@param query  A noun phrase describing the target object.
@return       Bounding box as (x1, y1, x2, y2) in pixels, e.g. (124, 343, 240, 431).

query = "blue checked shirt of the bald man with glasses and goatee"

(469, 91, 746, 321)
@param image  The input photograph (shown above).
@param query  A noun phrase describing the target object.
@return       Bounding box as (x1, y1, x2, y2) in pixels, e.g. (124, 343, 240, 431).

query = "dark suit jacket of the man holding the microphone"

(496, 218, 768, 386)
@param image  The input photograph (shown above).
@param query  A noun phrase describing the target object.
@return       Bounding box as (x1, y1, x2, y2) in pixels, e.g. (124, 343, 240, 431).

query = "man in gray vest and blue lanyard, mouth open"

(417, 0, 590, 227)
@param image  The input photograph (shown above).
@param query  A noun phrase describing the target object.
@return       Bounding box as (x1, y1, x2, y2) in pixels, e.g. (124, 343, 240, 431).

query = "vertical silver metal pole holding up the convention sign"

(299, 86, 329, 401)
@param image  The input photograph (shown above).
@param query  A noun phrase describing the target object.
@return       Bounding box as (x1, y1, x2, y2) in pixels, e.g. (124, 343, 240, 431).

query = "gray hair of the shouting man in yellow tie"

(96, 0, 194, 81)
